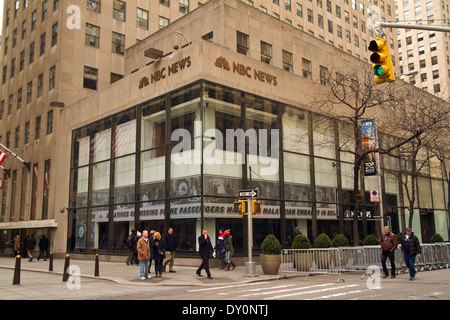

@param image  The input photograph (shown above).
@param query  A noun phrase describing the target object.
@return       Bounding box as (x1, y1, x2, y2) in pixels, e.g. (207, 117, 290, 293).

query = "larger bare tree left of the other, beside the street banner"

(311, 68, 448, 245)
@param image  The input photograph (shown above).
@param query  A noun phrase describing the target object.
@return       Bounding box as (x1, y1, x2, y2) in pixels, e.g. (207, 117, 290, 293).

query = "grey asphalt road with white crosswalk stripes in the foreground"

(95, 269, 450, 301)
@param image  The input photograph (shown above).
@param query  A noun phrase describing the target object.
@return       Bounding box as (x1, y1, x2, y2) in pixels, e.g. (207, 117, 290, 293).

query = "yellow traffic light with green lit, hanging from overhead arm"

(369, 37, 395, 84)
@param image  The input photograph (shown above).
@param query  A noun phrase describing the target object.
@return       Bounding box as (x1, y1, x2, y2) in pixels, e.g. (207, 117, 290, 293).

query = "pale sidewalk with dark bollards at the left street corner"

(0, 257, 288, 286)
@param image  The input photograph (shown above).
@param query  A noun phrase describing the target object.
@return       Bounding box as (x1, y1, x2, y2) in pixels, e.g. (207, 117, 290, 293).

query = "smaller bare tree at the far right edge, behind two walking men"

(382, 82, 450, 232)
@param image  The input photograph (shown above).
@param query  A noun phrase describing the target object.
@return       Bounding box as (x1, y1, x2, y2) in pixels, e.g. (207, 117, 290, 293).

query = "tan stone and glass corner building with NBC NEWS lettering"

(0, 0, 448, 255)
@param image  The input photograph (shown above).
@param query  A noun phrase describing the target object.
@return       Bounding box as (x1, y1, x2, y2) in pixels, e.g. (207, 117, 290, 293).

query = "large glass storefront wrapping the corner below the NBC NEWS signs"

(68, 82, 416, 254)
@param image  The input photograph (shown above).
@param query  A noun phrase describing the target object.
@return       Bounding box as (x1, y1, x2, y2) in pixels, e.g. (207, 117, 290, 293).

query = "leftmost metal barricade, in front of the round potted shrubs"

(280, 248, 344, 282)
